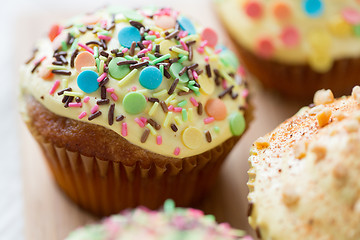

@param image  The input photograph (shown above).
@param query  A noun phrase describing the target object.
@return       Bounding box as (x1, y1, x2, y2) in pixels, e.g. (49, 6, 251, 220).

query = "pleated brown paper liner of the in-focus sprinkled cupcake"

(35, 132, 238, 216)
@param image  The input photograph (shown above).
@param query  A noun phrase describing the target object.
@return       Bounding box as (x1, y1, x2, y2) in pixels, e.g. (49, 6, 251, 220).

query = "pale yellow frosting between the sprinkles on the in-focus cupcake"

(21, 8, 247, 158)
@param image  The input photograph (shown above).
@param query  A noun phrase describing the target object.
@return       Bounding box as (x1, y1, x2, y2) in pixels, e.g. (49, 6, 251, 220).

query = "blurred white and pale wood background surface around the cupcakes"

(0, 0, 298, 240)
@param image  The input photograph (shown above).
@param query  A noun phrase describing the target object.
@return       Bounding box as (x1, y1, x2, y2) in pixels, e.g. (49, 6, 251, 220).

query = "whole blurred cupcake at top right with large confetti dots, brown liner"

(216, 0, 360, 100)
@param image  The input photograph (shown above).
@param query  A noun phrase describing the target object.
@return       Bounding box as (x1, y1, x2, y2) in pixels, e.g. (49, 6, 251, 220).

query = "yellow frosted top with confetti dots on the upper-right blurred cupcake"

(216, 0, 360, 72)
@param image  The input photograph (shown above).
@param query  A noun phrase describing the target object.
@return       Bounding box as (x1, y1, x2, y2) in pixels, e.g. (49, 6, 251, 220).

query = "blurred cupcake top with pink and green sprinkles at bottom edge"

(65, 200, 252, 240)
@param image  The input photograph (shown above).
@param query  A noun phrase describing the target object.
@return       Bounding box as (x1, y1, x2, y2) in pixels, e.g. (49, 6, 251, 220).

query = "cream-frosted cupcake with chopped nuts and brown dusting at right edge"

(248, 86, 360, 240)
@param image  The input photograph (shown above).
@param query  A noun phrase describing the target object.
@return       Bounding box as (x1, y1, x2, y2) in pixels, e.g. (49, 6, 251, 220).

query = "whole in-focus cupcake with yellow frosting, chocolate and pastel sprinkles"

(20, 7, 251, 215)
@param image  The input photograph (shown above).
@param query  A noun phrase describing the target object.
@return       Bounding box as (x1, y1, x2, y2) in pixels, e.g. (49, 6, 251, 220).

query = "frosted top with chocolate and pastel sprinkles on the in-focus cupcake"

(21, 7, 248, 158)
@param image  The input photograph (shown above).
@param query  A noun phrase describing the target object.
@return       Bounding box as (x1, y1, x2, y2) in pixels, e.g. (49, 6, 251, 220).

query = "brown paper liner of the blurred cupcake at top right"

(238, 42, 360, 100)
